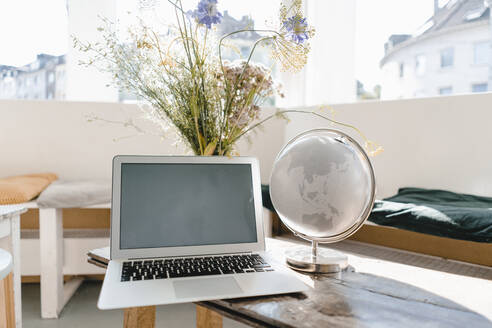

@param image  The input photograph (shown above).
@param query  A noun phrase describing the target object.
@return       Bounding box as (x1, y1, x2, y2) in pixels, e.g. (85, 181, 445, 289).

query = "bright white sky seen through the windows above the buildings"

(0, 0, 433, 90)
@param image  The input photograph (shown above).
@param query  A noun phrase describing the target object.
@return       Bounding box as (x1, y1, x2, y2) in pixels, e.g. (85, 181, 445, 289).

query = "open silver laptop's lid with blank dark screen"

(111, 156, 265, 259)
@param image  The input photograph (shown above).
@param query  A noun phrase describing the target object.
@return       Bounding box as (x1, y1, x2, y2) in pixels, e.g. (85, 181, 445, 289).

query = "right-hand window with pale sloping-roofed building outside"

(358, 0, 492, 101)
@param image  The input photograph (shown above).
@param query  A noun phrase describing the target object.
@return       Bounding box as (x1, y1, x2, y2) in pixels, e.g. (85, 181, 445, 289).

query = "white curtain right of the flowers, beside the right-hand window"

(278, 0, 356, 107)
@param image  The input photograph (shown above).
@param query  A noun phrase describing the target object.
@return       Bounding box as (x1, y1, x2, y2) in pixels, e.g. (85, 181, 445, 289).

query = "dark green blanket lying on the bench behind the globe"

(369, 188, 492, 243)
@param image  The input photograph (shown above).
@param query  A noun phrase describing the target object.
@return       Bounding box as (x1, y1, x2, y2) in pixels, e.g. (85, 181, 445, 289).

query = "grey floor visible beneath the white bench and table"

(22, 281, 246, 328)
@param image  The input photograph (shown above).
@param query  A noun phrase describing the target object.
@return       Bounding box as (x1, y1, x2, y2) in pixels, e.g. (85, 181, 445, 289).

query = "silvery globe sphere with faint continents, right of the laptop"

(270, 129, 375, 272)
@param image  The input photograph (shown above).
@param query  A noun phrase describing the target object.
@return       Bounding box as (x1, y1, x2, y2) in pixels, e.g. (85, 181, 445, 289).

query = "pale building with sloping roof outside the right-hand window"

(378, 0, 492, 100)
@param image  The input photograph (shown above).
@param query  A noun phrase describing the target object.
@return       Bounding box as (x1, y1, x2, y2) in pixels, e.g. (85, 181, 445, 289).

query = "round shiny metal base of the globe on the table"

(285, 240, 348, 273)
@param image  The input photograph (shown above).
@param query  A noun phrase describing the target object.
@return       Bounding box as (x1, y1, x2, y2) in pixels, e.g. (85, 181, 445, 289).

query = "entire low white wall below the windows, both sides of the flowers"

(0, 93, 492, 197)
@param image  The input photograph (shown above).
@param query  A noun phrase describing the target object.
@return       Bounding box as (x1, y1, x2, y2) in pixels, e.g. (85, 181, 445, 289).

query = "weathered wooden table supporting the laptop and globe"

(89, 239, 492, 328)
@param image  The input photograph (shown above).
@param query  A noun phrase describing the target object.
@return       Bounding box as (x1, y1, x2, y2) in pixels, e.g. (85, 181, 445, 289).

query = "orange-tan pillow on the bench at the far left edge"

(0, 173, 58, 205)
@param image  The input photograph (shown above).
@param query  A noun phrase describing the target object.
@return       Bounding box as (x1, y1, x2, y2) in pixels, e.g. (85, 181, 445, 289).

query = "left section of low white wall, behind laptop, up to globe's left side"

(0, 100, 284, 182)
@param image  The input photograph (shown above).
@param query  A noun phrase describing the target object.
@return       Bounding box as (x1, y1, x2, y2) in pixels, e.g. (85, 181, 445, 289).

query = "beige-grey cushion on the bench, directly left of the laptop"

(36, 180, 111, 208)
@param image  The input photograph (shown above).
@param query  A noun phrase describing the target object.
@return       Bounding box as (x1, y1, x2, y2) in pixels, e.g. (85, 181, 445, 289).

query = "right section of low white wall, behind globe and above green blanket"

(286, 93, 492, 197)
